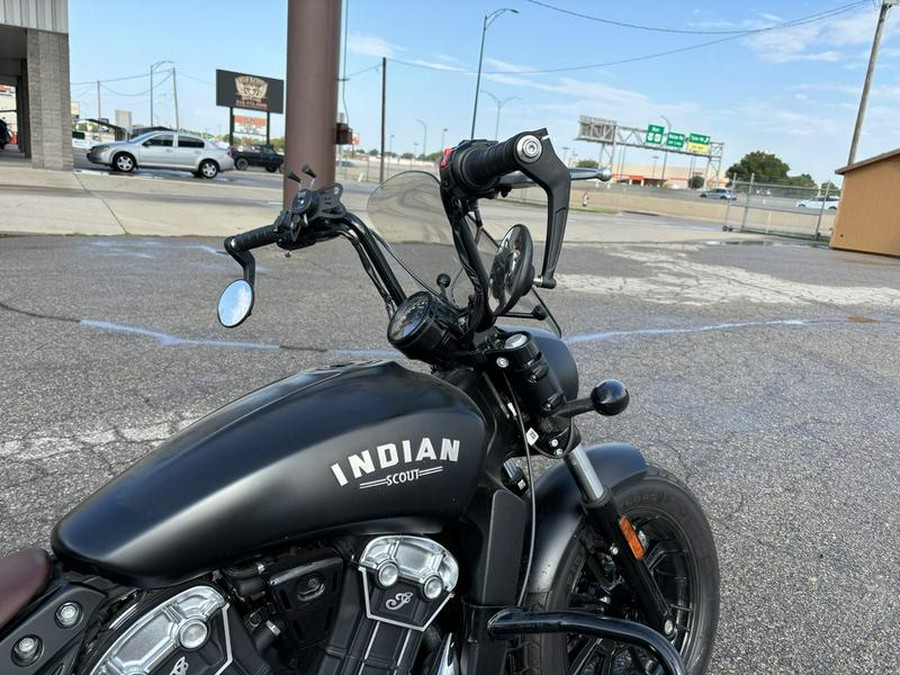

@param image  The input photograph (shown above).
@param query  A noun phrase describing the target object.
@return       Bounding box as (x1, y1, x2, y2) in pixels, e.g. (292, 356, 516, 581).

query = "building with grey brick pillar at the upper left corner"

(0, 0, 72, 169)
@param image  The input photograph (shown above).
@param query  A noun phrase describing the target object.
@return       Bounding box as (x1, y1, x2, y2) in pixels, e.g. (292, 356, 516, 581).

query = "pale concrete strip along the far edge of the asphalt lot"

(0, 162, 758, 243)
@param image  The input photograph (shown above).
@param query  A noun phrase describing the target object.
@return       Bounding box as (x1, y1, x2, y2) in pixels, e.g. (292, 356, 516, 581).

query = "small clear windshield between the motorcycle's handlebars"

(368, 171, 560, 335)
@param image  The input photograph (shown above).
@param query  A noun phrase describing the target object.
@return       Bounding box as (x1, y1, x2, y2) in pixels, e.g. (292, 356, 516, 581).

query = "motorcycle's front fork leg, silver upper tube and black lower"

(565, 445, 675, 637)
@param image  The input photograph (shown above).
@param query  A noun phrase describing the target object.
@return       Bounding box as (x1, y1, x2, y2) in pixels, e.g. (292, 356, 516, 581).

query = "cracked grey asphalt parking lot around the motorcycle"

(0, 232, 900, 675)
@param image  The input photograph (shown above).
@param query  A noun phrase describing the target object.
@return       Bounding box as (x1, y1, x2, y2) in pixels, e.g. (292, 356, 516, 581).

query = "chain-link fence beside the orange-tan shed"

(722, 178, 840, 239)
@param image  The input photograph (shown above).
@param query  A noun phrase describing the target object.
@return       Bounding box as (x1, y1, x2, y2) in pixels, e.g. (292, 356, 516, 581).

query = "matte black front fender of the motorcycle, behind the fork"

(528, 443, 647, 593)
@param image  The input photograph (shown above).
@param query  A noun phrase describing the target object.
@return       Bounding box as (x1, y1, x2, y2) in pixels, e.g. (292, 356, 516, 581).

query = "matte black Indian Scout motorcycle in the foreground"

(0, 129, 719, 675)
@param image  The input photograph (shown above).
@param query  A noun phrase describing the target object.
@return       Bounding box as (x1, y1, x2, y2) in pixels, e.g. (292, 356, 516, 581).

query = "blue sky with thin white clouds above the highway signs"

(69, 0, 900, 181)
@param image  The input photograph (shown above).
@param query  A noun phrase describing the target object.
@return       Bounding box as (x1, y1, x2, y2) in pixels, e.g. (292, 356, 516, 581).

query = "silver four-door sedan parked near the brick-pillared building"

(88, 131, 234, 178)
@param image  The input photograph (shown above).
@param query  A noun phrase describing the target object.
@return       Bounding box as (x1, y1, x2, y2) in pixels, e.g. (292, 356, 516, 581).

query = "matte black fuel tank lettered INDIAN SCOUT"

(52, 362, 487, 587)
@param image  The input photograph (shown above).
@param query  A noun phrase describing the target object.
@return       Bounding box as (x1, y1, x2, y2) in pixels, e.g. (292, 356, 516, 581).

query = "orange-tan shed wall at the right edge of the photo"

(831, 153, 900, 256)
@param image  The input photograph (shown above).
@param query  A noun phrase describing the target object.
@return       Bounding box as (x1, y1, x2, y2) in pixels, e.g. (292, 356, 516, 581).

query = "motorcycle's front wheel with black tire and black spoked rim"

(512, 466, 719, 675)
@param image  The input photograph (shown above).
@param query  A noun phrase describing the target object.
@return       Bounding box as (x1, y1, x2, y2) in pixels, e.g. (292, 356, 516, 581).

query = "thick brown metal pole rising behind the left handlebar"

(282, 0, 341, 208)
